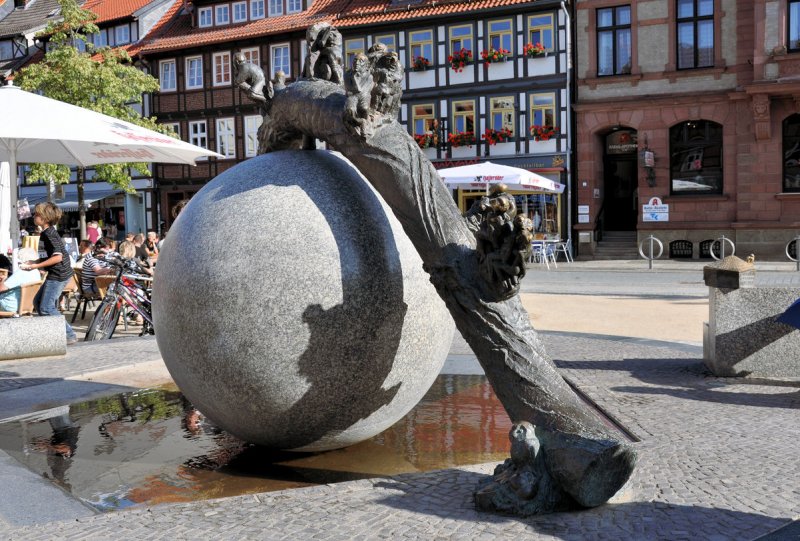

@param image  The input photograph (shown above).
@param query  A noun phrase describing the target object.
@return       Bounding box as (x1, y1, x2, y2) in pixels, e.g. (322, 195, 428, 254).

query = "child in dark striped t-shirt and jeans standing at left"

(20, 202, 78, 344)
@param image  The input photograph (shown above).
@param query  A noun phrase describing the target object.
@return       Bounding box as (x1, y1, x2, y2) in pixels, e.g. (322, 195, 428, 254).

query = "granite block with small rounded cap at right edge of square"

(703, 256, 800, 377)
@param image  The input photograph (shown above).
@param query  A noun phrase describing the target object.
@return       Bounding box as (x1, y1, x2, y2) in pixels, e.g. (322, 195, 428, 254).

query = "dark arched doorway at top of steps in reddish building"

(603, 128, 639, 231)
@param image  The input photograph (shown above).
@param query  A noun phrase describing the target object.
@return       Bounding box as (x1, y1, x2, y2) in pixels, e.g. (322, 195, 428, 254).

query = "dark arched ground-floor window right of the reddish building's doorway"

(669, 120, 722, 194)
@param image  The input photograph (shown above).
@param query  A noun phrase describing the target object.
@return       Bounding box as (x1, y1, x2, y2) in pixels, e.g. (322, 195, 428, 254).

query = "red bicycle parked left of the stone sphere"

(84, 257, 155, 342)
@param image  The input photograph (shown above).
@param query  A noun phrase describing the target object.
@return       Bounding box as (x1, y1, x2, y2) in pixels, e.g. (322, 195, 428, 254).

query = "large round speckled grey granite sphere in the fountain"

(153, 151, 454, 451)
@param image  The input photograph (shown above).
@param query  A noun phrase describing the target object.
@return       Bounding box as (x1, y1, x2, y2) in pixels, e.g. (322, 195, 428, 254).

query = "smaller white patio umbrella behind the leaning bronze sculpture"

(438, 162, 564, 193)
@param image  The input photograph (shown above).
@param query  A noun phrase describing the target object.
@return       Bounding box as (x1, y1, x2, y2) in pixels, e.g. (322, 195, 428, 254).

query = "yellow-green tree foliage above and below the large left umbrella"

(15, 0, 169, 192)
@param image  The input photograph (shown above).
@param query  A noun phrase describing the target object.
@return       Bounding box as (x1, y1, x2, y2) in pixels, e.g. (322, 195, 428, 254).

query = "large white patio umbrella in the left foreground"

(0, 84, 223, 245)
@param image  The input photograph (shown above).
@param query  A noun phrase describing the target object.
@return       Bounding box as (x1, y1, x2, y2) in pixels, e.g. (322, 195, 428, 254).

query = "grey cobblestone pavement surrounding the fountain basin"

(0, 332, 800, 541)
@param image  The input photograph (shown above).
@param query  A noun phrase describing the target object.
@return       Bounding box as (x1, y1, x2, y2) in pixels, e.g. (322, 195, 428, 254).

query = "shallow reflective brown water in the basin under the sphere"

(0, 376, 510, 511)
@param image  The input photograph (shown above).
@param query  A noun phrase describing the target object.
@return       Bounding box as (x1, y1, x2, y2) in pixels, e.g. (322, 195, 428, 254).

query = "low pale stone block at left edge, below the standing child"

(0, 316, 67, 360)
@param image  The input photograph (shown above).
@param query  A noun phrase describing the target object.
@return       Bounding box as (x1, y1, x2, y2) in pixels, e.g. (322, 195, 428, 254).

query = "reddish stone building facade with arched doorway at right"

(574, 0, 800, 259)
